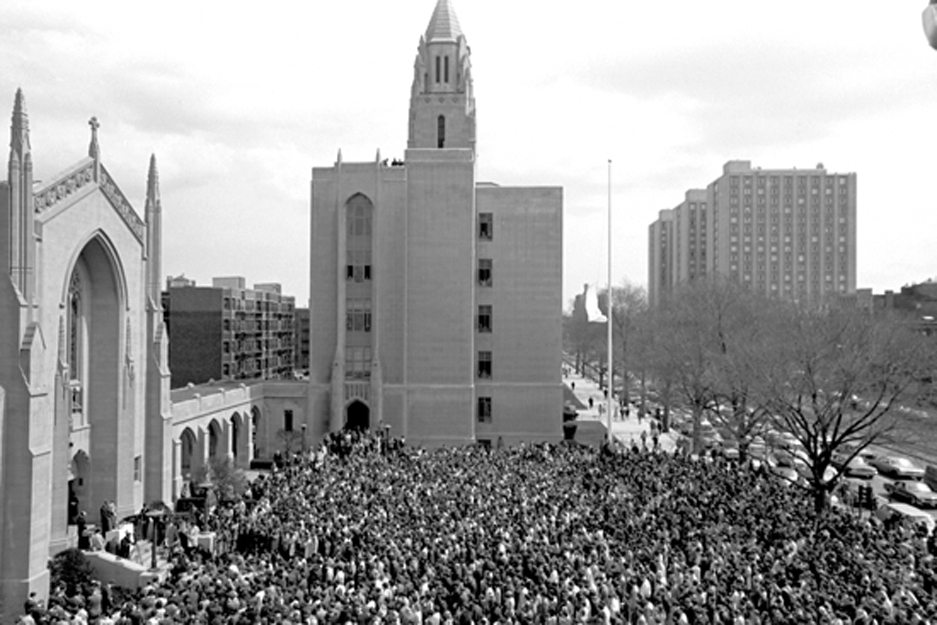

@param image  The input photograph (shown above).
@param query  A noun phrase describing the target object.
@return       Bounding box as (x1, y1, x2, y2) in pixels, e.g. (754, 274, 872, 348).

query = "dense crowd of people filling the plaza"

(16, 433, 937, 625)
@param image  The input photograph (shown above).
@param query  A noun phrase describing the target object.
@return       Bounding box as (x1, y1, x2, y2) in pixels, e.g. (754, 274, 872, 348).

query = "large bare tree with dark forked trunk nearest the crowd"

(759, 305, 933, 513)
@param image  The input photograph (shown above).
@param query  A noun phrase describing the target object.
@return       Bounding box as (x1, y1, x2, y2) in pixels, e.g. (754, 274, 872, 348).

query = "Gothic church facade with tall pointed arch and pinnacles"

(0, 91, 173, 609)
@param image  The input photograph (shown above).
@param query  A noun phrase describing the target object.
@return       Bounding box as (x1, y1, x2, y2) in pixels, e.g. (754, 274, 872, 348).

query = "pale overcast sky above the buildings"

(0, 0, 937, 307)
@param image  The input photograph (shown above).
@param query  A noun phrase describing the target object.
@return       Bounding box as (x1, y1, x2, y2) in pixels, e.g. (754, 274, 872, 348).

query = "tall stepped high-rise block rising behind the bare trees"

(648, 161, 856, 305)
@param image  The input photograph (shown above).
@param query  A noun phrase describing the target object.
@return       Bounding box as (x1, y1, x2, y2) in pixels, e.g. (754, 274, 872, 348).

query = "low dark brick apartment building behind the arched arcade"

(163, 277, 295, 388)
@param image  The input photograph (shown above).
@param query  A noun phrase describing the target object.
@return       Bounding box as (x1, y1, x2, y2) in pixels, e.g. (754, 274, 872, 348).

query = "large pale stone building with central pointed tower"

(308, 0, 563, 445)
